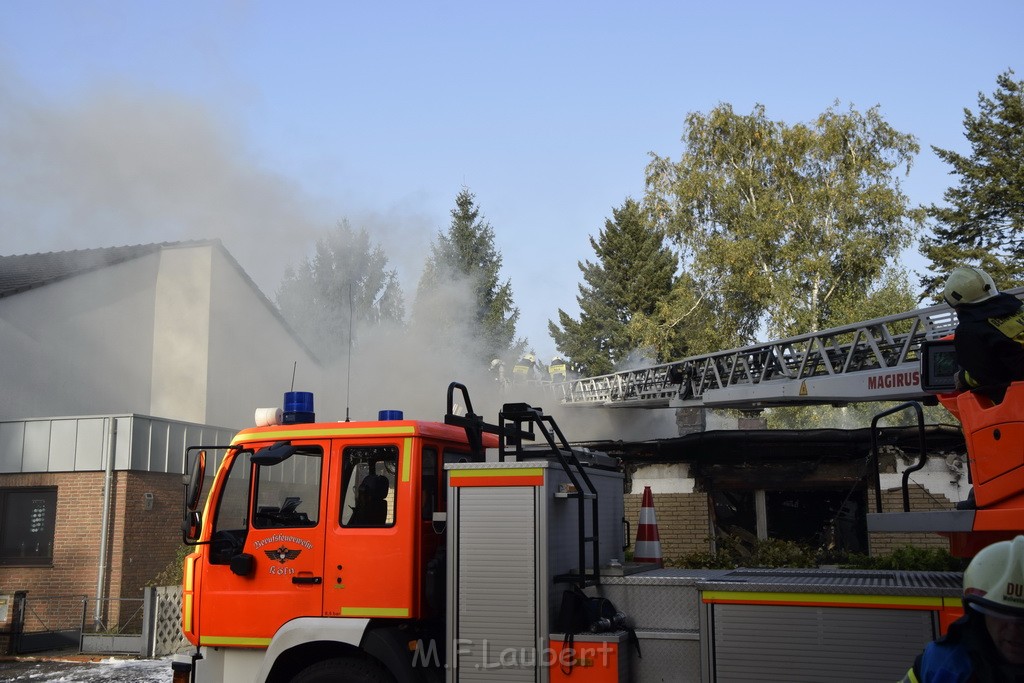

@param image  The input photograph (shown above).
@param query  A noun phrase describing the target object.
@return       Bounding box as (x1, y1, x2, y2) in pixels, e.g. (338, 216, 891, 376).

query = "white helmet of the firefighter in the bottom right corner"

(964, 536, 1024, 620)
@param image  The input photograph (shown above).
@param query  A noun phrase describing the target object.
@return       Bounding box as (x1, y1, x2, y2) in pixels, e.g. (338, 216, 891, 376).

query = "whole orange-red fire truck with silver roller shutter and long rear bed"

(172, 384, 961, 683)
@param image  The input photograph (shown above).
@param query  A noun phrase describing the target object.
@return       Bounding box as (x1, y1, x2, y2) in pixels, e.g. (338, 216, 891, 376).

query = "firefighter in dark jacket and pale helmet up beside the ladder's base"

(942, 267, 1024, 401)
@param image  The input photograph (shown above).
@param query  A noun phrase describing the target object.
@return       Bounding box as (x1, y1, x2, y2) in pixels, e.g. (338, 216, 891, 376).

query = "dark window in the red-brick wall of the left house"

(0, 488, 57, 565)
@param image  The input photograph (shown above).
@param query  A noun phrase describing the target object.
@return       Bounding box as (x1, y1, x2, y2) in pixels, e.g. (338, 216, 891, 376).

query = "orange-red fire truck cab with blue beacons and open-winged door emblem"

(174, 385, 498, 683)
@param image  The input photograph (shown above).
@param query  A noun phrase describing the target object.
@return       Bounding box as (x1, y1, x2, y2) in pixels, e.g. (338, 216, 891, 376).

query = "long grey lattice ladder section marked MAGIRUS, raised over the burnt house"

(546, 288, 1024, 409)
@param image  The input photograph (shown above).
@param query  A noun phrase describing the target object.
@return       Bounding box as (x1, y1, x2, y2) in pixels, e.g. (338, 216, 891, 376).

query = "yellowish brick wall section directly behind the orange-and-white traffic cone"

(625, 493, 711, 561)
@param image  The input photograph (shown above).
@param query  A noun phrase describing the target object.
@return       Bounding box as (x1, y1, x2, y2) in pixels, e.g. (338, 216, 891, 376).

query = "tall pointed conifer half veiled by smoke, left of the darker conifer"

(413, 187, 524, 360)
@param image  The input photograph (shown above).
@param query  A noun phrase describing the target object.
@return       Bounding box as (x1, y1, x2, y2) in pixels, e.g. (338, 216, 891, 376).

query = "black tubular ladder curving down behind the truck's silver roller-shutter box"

(499, 403, 601, 588)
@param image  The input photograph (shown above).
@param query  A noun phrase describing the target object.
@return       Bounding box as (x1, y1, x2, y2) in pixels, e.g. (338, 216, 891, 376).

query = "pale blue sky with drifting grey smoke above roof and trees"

(0, 0, 1024, 357)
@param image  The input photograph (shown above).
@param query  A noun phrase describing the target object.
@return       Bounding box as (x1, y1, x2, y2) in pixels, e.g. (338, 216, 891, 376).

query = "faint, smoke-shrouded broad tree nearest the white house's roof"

(276, 220, 406, 361)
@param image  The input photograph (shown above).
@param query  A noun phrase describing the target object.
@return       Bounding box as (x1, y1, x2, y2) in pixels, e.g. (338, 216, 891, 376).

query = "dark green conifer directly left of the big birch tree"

(548, 199, 682, 376)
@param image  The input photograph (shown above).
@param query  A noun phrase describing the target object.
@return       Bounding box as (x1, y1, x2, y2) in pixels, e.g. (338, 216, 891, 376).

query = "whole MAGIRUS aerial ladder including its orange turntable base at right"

(549, 288, 1024, 557)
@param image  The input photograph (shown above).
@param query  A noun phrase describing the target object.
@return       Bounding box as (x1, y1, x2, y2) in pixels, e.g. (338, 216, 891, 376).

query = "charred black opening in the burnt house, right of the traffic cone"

(711, 486, 867, 553)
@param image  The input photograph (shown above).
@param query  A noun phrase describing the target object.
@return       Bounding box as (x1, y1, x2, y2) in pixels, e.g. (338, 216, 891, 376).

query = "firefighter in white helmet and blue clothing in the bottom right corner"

(903, 536, 1024, 683)
